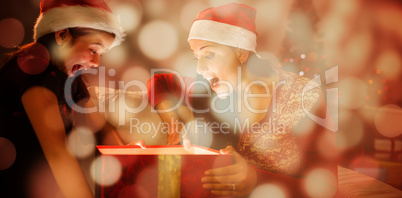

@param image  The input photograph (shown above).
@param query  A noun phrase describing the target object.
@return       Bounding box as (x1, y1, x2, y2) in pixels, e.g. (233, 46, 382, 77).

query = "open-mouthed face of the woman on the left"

(56, 32, 114, 77)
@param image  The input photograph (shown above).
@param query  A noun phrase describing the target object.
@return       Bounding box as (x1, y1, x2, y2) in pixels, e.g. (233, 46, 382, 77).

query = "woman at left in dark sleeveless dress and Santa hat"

(0, 0, 123, 198)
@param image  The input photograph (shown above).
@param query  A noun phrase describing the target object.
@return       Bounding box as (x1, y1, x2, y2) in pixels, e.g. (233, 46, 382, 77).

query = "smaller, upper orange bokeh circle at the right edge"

(376, 51, 402, 80)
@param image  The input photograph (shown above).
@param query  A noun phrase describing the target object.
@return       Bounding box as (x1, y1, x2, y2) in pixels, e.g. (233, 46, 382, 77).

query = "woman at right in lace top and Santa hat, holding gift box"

(148, 3, 337, 197)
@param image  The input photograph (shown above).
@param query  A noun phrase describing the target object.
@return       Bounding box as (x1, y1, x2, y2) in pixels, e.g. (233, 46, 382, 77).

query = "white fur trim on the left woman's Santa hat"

(34, 6, 125, 48)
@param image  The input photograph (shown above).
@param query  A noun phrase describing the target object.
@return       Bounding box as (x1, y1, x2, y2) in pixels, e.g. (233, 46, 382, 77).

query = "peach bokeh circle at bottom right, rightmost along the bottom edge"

(304, 168, 337, 197)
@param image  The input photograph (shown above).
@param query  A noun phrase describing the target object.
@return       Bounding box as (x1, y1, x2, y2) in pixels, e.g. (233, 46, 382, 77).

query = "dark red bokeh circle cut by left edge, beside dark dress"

(0, 137, 17, 170)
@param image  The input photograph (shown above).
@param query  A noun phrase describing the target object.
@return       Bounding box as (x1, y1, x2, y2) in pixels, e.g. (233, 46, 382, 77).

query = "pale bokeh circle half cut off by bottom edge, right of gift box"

(250, 184, 288, 198)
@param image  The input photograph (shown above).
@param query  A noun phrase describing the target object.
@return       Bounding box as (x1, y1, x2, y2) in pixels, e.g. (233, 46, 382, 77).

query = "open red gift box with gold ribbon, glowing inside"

(95, 145, 231, 198)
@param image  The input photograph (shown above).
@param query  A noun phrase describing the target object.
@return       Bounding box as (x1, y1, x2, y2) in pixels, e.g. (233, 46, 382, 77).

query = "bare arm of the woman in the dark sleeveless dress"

(21, 86, 93, 198)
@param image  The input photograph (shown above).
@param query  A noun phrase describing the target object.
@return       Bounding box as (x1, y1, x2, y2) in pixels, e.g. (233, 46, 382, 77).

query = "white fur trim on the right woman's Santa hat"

(188, 20, 257, 53)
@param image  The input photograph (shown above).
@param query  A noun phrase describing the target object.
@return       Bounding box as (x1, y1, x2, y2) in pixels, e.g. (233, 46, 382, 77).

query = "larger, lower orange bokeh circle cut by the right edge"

(374, 104, 402, 138)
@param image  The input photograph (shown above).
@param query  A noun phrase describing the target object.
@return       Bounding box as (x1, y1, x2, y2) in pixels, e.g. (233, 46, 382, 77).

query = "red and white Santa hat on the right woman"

(188, 3, 258, 53)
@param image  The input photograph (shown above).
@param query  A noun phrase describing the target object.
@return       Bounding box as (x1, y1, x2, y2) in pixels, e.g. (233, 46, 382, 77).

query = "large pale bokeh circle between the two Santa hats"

(138, 21, 178, 60)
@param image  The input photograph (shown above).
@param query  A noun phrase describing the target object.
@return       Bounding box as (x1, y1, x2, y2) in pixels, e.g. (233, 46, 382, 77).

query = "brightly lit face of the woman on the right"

(189, 39, 241, 98)
